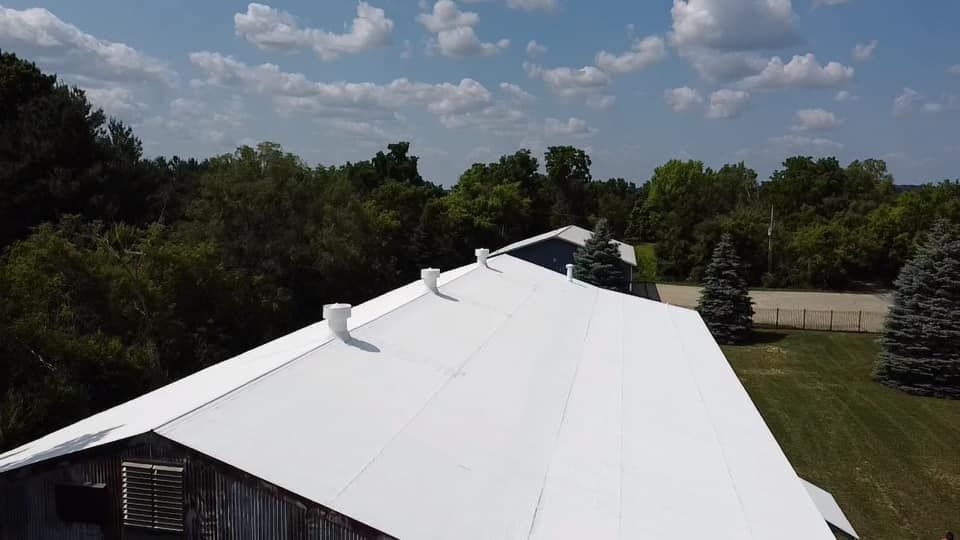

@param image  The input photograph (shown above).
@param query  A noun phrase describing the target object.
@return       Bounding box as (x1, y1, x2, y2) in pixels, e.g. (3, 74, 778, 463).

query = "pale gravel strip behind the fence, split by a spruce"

(657, 284, 891, 313)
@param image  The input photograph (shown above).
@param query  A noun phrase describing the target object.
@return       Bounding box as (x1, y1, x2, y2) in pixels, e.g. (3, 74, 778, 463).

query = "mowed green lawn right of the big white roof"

(724, 332, 960, 540)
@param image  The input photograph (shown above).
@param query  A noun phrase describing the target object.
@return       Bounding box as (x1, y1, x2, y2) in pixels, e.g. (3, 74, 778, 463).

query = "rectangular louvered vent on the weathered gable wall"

(123, 461, 183, 532)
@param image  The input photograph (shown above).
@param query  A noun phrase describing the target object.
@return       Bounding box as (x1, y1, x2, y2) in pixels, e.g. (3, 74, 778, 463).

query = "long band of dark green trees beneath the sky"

(0, 52, 960, 448)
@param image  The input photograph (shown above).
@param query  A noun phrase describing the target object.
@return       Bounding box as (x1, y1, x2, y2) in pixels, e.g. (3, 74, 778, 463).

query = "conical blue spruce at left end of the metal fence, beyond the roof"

(697, 234, 753, 344)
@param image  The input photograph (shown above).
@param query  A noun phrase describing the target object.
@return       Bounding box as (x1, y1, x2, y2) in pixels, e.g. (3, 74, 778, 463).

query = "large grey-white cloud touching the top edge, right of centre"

(670, 0, 798, 51)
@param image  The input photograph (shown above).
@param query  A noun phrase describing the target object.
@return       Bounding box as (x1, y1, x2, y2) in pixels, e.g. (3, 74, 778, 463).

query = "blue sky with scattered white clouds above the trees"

(0, 0, 960, 185)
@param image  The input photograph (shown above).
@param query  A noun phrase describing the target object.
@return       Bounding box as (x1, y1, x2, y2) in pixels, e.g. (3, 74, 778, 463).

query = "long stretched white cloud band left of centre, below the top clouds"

(190, 51, 492, 116)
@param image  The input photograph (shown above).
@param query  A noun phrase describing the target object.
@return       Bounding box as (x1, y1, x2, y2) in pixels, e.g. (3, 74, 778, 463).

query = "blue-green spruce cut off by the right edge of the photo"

(875, 221, 960, 399)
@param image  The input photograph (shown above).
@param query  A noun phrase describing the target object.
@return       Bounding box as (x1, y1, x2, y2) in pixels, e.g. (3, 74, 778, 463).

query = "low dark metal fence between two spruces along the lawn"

(753, 308, 886, 333)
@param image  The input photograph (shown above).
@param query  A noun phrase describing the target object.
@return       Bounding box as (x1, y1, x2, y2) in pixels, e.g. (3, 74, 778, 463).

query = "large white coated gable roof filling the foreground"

(0, 255, 832, 540)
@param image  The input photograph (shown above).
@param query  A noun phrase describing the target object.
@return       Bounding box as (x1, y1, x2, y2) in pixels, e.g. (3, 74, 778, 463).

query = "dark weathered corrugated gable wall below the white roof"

(0, 435, 390, 540)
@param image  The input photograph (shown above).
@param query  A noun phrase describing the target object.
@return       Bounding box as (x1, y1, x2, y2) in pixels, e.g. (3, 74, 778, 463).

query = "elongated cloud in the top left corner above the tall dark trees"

(0, 6, 178, 87)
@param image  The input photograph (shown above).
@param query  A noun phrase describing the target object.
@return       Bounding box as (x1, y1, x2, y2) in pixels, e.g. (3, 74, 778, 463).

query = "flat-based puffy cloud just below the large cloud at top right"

(740, 54, 854, 89)
